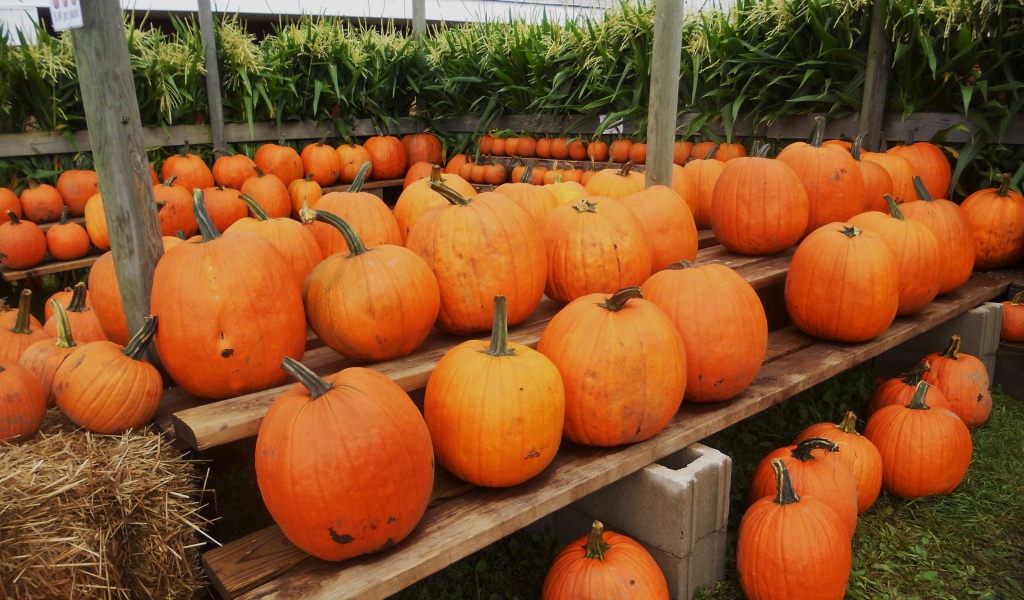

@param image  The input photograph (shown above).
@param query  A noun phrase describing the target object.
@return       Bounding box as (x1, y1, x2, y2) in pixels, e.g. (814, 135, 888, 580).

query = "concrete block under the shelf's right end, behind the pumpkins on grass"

(873, 302, 1002, 378)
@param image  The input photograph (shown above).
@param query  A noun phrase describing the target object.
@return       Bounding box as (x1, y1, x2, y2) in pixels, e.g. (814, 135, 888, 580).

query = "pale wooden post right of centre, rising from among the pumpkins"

(646, 0, 683, 187)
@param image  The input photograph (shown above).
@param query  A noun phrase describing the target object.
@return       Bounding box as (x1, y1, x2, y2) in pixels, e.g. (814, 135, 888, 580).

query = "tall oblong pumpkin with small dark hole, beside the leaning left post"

(149, 190, 306, 398)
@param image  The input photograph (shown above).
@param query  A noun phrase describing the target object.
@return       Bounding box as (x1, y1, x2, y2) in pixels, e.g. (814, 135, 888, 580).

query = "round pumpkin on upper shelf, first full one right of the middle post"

(711, 146, 806, 255)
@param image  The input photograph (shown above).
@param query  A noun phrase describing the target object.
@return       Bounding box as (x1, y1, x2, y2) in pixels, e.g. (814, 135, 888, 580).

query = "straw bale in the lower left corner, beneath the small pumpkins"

(0, 410, 209, 599)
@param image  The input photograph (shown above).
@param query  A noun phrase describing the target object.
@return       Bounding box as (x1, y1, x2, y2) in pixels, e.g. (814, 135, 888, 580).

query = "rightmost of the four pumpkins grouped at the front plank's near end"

(643, 262, 768, 402)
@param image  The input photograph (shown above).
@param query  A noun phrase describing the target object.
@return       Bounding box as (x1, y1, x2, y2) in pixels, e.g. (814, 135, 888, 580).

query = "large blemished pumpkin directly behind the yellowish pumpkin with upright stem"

(406, 182, 547, 334)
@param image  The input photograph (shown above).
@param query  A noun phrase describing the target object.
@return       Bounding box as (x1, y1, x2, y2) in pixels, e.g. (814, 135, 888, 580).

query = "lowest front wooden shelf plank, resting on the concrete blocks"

(209, 272, 1010, 599)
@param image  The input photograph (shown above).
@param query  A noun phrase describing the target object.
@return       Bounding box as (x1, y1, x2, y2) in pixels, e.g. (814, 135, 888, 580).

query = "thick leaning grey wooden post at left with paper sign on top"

(72, 0, 164, 341)
